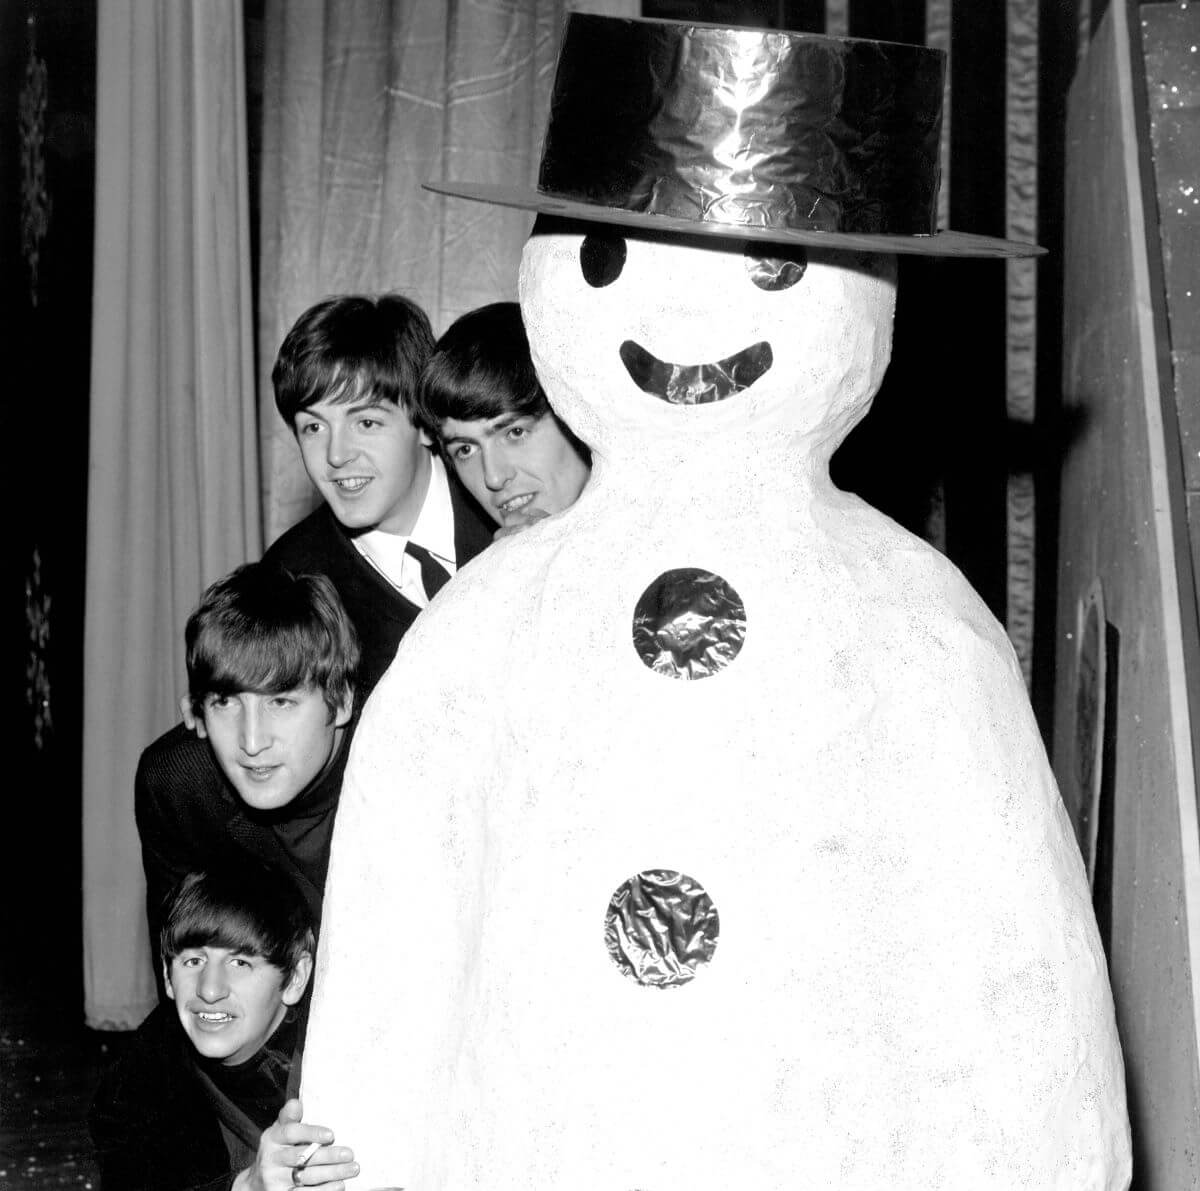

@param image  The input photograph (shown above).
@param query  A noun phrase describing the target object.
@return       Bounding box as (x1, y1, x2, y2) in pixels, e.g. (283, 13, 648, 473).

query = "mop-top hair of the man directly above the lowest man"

(184, 562, 359, 719)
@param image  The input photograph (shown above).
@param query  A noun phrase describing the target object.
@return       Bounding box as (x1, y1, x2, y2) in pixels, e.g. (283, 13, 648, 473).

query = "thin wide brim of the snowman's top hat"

(424, 181, 1046, 258)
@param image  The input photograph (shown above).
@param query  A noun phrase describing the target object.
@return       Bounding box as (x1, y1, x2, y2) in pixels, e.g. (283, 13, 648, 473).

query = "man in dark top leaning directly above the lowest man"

(134, 562, 359, 971)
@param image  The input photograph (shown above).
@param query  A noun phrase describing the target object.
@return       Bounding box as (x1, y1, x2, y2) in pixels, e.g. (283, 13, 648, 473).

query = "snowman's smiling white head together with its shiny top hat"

(427, 13, 1040, 470)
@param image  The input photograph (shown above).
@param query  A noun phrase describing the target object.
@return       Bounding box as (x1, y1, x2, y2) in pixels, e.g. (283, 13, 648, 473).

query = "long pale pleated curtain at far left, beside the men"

(83, 0, 260, 1028)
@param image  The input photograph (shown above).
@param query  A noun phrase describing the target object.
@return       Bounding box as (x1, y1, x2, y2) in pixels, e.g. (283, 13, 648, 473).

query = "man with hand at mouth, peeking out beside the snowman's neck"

(416, 301, 592, 537)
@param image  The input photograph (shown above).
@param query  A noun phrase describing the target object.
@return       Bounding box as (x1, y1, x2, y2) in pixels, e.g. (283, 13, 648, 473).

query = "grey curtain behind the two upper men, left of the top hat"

(258, 0, 637, 541)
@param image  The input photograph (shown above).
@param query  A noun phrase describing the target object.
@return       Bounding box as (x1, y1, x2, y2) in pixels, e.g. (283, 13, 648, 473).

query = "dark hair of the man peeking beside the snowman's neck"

(414, 301, 551, 436)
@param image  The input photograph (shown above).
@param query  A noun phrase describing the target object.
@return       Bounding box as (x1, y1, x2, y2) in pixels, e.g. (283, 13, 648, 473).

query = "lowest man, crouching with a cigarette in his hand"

(88, 862, 358, 1191)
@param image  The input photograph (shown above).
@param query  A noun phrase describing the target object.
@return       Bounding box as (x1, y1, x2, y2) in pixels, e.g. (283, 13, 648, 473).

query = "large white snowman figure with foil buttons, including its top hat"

(301, 14, 1130, 1191)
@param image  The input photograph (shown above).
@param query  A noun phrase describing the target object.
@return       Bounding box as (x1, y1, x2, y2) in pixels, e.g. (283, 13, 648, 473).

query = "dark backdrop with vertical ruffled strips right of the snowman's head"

(792, 0, 1065, 735)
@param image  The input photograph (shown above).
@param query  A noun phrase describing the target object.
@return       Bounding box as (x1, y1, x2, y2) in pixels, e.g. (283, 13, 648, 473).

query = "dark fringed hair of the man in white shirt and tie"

(271, 294, 433, 426)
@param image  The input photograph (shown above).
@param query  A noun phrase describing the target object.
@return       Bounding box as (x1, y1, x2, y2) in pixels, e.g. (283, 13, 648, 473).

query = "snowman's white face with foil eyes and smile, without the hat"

(521, 217, 895, 457)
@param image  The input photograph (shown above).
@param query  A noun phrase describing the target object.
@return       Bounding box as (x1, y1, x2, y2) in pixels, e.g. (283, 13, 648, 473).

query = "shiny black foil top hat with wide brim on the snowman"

(426, 13, 1044, 257)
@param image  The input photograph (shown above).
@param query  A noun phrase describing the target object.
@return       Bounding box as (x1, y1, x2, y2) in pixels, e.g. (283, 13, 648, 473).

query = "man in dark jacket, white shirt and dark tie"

(265, 294, 492, 698)
